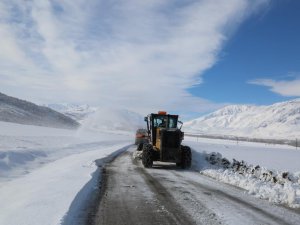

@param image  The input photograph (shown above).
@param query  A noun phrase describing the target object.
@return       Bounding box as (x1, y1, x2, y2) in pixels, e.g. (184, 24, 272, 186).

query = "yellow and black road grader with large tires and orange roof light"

(142, 111, 192, 169)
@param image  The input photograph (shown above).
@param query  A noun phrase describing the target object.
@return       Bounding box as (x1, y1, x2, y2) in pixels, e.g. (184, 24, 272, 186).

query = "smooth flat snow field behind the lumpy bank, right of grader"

(185, 137, 300, 172)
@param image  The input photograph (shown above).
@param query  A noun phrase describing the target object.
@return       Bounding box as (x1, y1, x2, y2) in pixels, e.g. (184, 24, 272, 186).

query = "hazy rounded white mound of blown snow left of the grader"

(81, 108, 145, 133)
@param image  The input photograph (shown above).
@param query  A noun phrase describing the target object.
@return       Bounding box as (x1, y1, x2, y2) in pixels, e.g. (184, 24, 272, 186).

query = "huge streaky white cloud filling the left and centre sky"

(0, 0, 269, 113)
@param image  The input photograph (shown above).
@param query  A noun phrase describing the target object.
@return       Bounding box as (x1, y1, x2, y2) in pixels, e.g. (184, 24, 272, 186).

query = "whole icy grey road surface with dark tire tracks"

(91, 147, 300, 225)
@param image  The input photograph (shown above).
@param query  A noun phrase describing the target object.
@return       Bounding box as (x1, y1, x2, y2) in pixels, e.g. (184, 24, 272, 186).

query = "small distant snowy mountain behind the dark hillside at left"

(44, 103, 97, 122)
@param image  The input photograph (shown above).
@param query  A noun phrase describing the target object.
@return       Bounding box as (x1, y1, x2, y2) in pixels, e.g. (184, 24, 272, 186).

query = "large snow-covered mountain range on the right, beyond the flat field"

(183, 99, 300, 139)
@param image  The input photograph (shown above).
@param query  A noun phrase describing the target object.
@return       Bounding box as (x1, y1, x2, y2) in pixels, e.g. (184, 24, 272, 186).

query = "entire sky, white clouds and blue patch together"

(0, 0, 300, 118)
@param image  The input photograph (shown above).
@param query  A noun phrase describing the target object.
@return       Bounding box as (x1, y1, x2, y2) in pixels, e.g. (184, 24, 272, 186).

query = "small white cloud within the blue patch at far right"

(249, 79, 300, 97)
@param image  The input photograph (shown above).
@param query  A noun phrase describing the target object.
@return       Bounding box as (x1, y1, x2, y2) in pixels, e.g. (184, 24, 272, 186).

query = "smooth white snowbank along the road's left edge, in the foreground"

(0, 144, 128, 225)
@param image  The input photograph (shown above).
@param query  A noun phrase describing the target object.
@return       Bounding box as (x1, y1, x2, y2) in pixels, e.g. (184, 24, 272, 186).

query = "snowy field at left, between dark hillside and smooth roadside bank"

(0, 122, 132, 183)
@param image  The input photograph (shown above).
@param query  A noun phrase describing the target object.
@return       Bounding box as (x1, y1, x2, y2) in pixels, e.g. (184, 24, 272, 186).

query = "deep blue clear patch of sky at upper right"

(190, 0, 300, 104)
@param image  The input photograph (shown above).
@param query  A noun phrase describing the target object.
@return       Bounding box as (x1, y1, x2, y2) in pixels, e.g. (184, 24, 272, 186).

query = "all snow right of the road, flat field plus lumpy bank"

(185, 138, 300, 208)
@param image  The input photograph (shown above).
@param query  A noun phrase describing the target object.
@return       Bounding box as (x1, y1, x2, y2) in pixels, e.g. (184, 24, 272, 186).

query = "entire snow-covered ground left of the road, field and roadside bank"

(0, 122, 133, 225)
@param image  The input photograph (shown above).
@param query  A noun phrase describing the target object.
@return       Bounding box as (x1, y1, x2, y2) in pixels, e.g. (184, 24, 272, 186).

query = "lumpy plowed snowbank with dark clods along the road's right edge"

(195, 152, 300, 208)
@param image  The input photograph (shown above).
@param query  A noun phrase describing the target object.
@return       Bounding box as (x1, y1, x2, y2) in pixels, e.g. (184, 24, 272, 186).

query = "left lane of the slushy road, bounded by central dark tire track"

(94, 149, 196, 225)
